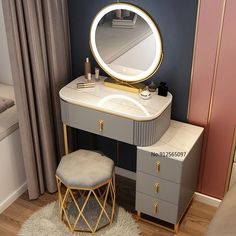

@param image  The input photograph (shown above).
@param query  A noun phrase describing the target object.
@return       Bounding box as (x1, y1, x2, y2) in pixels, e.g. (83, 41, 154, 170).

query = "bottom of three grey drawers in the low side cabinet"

(135, 192, 178, 224)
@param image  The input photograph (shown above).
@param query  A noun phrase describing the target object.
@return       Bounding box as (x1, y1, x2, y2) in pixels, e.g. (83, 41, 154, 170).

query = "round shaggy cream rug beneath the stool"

(18, 202, 140, 236)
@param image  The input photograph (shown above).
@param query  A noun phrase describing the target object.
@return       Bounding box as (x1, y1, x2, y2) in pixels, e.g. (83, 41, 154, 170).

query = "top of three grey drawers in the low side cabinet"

(137, 149, 182, 183)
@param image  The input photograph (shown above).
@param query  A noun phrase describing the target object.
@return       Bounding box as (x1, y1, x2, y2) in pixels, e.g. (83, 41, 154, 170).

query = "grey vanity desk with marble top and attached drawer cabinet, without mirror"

(60, 76, 203, 231)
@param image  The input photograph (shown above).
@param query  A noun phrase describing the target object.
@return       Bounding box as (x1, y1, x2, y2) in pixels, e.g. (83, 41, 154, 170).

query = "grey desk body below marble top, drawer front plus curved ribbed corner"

(61, 100, 171, 146)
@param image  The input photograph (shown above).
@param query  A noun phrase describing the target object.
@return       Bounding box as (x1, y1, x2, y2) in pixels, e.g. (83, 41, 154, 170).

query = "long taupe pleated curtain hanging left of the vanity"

(2, 0, 71, 199)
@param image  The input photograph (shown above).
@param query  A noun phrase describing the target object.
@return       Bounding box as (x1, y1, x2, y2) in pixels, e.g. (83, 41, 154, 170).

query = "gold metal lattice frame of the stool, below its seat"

(56, 171, 116, 234)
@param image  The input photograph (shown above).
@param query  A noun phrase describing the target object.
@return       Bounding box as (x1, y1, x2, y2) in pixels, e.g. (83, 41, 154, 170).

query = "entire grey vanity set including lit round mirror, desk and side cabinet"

(60, 3, 203, 232)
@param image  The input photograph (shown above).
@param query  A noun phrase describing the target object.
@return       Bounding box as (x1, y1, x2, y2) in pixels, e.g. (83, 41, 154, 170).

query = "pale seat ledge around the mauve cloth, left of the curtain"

(0, 83, 18, 141)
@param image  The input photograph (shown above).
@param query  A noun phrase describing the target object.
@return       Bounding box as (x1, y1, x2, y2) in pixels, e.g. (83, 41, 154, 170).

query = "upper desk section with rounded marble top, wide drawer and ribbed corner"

(60, 76, 172, 146)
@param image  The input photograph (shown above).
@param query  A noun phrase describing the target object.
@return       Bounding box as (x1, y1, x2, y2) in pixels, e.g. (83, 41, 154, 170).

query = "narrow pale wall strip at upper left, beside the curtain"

(0, 1, 13, 84)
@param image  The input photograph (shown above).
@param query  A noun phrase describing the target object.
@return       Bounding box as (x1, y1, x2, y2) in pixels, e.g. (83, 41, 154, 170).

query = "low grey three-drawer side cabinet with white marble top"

(135, 121, 203, 225)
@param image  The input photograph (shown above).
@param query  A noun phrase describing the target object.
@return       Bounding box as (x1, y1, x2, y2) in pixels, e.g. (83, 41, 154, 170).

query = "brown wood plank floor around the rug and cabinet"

(0, 178, 216, 236)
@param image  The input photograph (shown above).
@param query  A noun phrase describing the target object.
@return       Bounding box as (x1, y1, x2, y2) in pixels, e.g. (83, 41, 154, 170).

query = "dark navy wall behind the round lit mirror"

(68, 0, 198, 121)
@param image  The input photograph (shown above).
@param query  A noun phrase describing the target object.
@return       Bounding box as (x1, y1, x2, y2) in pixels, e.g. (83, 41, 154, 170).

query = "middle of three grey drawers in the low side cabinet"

(136, 172, 180, 204)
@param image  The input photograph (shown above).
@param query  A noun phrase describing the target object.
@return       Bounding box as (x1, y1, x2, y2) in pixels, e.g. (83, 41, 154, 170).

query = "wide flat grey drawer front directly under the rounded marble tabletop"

(61, 100, 133, 144)
